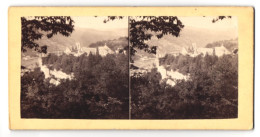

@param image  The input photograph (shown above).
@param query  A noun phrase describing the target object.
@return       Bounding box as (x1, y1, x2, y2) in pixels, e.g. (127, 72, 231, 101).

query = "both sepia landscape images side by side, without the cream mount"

(21, 16, 238, 119)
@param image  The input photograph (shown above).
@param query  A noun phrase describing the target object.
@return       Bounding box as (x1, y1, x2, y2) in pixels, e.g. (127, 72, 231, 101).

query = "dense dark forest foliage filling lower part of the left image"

(21, 54, 129, 119)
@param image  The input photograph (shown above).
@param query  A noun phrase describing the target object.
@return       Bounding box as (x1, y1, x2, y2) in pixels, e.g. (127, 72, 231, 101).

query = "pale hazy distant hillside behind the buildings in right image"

(144, 27, 238, 54)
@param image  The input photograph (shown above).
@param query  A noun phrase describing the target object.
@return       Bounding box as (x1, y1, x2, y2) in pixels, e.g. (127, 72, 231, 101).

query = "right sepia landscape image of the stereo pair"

(129, 16, 238, 119)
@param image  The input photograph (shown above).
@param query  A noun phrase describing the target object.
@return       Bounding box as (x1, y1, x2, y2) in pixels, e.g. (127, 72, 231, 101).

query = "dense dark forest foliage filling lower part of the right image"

(131, 55, 238, 119)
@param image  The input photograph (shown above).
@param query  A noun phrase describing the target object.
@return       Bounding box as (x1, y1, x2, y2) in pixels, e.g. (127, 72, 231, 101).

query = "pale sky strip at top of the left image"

(72, 16, 128, 30)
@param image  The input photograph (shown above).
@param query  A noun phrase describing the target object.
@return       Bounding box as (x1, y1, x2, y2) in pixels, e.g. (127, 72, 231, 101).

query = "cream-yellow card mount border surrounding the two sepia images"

(8, 7, 254, 130)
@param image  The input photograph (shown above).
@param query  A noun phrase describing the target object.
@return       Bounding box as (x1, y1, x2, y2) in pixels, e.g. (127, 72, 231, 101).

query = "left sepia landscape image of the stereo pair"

(21, 16, 129, 119)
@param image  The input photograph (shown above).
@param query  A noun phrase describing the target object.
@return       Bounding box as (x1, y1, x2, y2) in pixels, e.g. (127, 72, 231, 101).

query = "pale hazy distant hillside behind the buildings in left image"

(33, 28, 128, 51)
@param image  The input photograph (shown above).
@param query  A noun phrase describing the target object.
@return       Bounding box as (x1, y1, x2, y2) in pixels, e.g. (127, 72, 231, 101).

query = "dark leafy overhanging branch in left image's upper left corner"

(21, 16, 74, 53)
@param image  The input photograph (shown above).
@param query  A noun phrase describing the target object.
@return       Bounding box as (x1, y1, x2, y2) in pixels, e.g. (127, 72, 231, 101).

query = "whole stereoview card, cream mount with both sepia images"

(8, 7, 254, 130)
